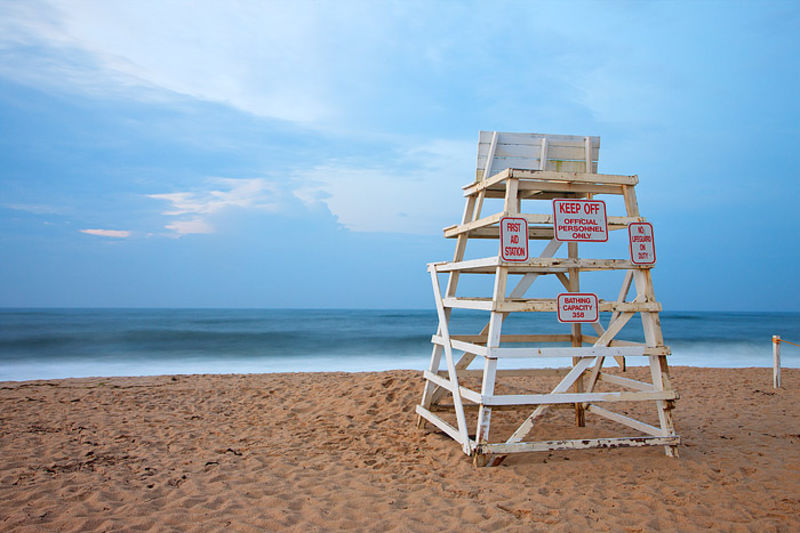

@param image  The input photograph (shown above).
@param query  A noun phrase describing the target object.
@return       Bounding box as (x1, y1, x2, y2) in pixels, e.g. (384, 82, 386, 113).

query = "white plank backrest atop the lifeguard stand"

(475, 131, 600, 180)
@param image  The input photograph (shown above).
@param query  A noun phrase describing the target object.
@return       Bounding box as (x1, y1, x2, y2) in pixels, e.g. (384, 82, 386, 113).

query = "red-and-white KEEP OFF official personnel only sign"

(553, 200, 608, 242)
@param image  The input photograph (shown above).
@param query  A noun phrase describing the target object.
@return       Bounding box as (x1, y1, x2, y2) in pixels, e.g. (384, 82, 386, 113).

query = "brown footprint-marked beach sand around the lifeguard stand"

(0, 367, 800, 531)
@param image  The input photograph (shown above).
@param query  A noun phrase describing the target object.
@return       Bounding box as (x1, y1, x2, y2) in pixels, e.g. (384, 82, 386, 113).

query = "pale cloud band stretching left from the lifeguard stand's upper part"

(147, 139, 475, 237)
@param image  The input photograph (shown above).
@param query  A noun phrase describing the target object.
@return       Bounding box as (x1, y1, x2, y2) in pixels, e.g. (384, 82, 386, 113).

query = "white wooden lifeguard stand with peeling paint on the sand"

(416, 131, 680, 465)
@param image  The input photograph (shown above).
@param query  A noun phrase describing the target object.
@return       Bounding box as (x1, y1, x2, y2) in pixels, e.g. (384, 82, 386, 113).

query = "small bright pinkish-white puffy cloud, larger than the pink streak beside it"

(148, 178, 280, 236)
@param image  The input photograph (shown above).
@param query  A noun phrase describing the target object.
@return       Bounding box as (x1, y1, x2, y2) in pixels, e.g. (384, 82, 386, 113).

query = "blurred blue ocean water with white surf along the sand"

(0, 309, 800, 381)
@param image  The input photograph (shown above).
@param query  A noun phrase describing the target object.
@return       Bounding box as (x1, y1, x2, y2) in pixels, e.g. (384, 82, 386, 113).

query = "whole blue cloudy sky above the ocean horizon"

(0, 0, 800, 311)
